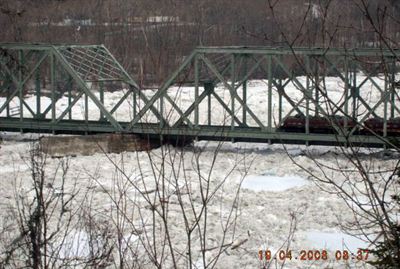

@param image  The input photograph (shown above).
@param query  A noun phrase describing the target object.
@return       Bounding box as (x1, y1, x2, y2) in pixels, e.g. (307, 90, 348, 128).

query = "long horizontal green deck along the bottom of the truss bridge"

(0, 118, 395, 148)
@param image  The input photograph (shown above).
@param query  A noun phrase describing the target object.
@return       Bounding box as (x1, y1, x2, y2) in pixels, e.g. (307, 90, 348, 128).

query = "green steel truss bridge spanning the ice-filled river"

(0, 44, 400, 147)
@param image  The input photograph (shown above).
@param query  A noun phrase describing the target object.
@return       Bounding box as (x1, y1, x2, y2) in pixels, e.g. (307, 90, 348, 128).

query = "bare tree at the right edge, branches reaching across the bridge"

(267, 0, 400, 268)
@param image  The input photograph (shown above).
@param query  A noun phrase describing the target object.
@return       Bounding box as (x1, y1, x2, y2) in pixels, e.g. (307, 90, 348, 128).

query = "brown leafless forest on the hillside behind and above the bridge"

(0, 0, 400, 85)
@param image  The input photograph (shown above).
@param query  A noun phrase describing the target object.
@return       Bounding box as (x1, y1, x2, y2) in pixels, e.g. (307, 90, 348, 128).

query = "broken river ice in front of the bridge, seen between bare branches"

(0, 136, 395, 268)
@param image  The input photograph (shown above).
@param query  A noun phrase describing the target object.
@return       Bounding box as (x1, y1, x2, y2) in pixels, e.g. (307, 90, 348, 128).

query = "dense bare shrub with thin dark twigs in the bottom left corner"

(0, 142, 112, 269)
